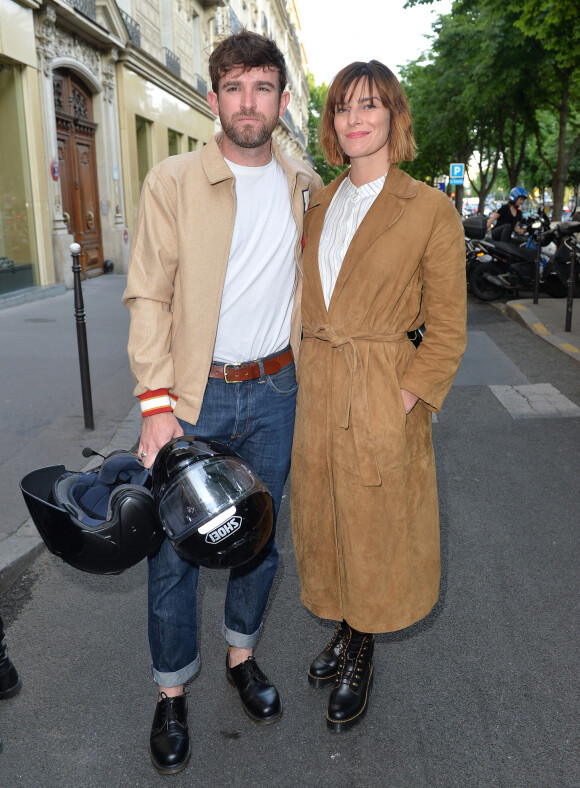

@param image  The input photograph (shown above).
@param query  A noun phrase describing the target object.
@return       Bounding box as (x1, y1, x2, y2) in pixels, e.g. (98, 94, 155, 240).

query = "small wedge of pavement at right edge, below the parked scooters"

(494, 298, 580, 361)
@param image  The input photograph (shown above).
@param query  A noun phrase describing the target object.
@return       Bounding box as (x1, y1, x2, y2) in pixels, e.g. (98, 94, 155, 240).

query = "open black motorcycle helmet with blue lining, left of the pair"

(20, 451, 165, 575)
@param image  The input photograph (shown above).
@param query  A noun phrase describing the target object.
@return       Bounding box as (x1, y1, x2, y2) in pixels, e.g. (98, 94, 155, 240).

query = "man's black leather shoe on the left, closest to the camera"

(149, 692, 191, 774)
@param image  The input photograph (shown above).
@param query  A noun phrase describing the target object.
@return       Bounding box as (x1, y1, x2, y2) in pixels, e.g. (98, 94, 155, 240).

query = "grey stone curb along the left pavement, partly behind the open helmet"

(0, 403, 142, 595)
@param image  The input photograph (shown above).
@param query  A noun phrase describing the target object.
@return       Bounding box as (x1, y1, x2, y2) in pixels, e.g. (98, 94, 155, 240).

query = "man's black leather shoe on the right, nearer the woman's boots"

(226, 651, 282, 725)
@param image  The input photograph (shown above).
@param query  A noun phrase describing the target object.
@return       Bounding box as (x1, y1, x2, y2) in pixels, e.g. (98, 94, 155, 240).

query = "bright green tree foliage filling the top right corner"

(407, 0, 580, 217)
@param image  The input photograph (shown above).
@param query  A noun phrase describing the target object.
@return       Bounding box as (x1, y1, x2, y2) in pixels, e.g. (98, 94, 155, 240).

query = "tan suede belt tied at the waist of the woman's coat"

(302, 325, 408, 487)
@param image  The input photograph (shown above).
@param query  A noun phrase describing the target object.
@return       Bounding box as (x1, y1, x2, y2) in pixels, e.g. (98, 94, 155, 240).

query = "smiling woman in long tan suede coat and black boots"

(292, 61, 465, 731)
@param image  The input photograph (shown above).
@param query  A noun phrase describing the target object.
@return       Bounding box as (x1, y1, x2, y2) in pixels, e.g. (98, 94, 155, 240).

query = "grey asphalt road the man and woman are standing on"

(0, 301, 580, 788)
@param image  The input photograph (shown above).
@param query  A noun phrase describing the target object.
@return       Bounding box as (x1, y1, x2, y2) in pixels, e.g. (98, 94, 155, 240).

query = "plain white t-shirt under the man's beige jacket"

(213, 157, 298, 363)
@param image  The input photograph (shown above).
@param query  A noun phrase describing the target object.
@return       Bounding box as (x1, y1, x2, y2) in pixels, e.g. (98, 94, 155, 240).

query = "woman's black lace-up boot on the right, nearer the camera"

(326, 632, 374, 733)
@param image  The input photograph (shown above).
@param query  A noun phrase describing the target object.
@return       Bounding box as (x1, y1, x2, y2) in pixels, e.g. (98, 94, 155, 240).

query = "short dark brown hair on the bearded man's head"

(209, 30, 288, 93)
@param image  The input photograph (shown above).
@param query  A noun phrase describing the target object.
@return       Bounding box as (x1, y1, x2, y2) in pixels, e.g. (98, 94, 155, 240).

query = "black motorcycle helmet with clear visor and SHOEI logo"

(153, 435, 274, 569)
